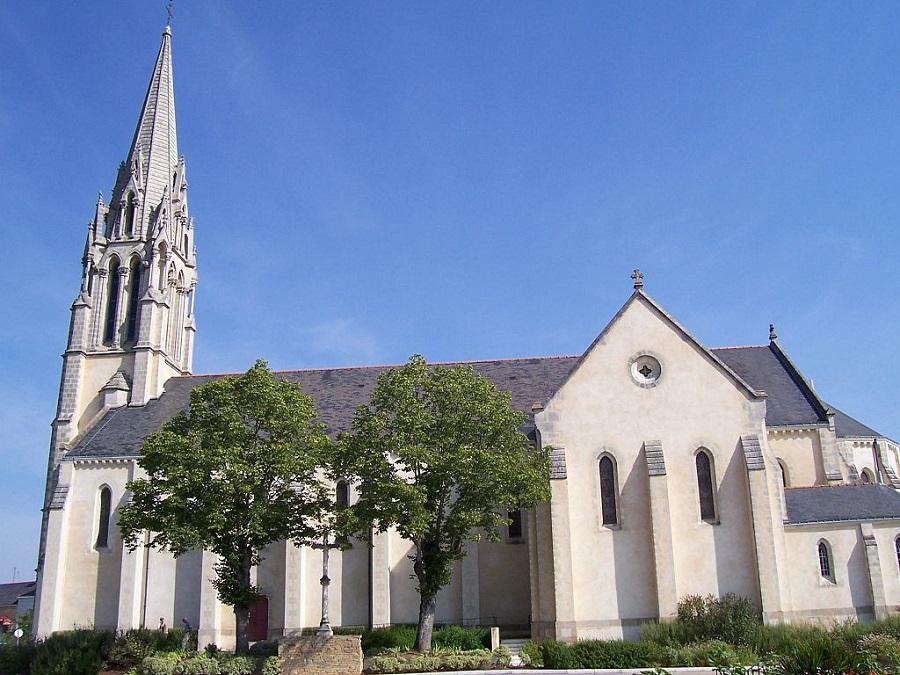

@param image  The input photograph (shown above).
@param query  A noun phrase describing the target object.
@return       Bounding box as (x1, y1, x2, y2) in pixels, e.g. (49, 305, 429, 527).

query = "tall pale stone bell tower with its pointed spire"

(39, 25, 197, 567)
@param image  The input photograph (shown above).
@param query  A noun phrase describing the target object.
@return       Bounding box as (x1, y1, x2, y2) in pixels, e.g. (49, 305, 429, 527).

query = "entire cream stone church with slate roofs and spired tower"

(35, 27, 900, 647)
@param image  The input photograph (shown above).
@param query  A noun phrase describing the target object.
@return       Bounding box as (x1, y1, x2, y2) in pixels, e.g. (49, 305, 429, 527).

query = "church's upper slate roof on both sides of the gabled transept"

(68, 345, 880, 458)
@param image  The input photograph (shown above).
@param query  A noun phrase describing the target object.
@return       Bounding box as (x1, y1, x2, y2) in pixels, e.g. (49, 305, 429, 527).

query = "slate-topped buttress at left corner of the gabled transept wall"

(550, 448, 578, 642)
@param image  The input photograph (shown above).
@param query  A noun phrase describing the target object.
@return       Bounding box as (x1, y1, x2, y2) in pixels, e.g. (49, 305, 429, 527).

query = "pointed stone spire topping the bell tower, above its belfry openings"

(110, 25, 178, 233)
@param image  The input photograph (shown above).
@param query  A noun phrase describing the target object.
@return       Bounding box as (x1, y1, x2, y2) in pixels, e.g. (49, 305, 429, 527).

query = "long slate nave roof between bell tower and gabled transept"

(67, 356, 578, 458)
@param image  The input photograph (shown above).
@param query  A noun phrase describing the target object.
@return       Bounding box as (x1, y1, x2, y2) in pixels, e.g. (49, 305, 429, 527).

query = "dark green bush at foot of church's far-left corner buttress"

(31, 629, 115, 675)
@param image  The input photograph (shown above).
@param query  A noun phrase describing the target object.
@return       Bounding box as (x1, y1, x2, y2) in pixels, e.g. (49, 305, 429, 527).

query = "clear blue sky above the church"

(0, 0, 900, 581)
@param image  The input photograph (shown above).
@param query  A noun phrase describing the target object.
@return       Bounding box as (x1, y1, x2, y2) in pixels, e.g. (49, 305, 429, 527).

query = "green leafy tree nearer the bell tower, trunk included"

(119, 361, 333, 651)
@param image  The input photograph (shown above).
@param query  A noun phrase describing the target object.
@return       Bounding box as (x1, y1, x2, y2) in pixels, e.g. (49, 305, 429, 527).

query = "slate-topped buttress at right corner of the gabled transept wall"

(741, 435, 785, 623)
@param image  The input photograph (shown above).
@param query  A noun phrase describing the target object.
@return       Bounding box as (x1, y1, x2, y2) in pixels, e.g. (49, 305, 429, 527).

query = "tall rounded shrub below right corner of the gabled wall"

(676, 593, 762, 645)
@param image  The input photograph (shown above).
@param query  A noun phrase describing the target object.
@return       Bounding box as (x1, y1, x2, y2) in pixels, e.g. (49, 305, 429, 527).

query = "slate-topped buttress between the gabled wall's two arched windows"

(644, 441, 678, 621)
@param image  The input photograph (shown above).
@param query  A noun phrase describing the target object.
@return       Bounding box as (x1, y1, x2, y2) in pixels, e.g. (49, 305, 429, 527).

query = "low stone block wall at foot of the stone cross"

(278, 635, 362, 675)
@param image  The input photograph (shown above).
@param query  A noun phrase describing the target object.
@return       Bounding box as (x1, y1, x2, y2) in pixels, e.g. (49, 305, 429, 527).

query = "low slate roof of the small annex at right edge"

(784, 485, 900, 525)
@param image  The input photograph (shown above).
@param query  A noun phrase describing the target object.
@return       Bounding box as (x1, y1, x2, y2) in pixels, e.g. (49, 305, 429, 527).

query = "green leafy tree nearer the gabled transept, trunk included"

(334, 356, 550, 651)
